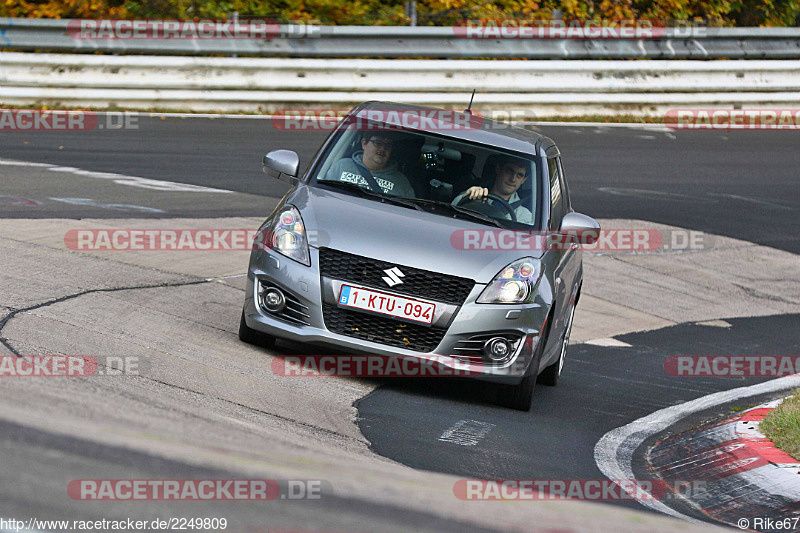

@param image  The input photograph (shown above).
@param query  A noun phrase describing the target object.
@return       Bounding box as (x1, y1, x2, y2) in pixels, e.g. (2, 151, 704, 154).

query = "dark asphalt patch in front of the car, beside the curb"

(356, 314, 800, 518)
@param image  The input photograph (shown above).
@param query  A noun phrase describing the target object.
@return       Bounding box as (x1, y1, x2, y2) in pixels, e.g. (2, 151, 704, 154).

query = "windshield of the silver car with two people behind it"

(311, 123, 540, 228)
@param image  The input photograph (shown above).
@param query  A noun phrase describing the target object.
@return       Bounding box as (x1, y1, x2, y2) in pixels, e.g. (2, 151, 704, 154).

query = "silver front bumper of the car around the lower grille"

(244, 248, 549, 384)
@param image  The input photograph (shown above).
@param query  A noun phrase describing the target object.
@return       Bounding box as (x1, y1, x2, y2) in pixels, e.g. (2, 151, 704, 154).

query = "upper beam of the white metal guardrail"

(6, 52, 800, 92)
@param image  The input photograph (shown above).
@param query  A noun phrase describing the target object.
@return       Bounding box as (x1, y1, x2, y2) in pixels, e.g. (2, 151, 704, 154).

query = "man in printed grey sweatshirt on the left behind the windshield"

(325, 131, 415, 198)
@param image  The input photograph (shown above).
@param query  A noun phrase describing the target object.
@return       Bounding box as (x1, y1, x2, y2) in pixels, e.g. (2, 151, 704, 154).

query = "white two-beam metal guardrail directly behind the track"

(0, 52, 800, 115)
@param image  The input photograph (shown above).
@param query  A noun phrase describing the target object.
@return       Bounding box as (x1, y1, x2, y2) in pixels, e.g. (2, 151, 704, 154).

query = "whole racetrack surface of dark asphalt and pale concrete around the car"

(0, 115, 800, 531)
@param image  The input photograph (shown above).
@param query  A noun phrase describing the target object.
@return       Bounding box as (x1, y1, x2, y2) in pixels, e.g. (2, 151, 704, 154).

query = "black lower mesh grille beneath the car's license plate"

(322, 304, 447, 352)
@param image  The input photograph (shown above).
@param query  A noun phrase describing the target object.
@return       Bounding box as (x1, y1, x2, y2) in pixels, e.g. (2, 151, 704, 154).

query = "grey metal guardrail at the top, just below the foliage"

(0, 18, 800, 59)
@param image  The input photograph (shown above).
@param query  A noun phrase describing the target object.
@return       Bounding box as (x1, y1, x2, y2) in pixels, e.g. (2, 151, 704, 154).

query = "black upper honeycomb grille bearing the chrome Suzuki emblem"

(319, 248, 475, 306)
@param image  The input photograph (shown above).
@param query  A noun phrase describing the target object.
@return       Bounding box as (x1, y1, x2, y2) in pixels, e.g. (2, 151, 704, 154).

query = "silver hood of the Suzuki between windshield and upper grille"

(286, 185, 542, 283)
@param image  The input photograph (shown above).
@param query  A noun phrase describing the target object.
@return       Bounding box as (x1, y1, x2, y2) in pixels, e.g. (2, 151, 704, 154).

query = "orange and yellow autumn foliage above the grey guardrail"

(0, 0, 800, 26)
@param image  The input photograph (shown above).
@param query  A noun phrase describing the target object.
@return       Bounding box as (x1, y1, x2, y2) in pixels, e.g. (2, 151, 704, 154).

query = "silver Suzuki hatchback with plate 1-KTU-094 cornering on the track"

(239, 102, 600, 411)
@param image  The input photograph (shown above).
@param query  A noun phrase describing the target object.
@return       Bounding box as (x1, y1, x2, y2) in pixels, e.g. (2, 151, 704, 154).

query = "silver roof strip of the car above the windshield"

(348, 101, 558, 156)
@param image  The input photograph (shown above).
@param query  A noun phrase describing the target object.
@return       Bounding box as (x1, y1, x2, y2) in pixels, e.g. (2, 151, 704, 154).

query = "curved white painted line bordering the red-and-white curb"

(594, 374, 800, 524)
